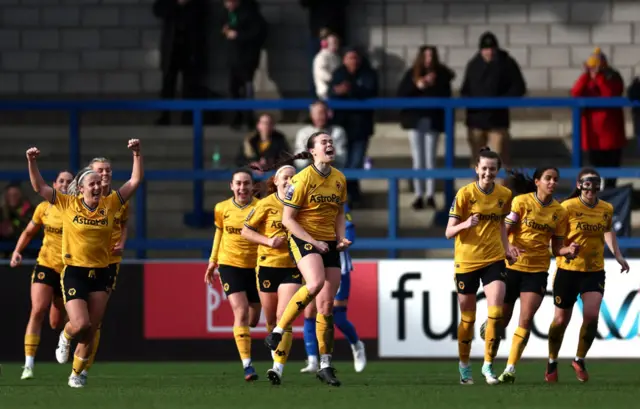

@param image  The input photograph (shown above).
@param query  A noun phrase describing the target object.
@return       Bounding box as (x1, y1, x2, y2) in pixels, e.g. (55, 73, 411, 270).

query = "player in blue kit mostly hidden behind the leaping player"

(300, 205, 367, 373)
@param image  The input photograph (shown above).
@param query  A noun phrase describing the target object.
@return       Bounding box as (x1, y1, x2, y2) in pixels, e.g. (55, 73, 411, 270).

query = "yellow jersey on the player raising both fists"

(51, 190, 124, 268)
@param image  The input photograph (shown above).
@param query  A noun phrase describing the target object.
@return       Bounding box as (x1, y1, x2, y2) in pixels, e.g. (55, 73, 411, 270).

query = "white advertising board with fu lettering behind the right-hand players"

(378, 260, 640, 358)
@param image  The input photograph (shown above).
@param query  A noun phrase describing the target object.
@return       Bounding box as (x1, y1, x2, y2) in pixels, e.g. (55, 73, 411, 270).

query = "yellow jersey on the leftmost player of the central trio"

(212, 197, 259, 268)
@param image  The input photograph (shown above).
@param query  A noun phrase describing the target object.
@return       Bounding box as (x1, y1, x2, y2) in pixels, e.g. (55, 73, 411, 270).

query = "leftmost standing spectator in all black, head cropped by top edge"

(153, 0, 209, 125)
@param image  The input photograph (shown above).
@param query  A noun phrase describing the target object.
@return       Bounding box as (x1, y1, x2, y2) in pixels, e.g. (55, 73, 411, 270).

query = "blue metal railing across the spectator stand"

(0, 98, 640, 258)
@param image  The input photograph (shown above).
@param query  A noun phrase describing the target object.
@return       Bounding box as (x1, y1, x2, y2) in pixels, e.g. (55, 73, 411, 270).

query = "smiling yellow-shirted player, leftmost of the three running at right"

(445, 148, 517, 385)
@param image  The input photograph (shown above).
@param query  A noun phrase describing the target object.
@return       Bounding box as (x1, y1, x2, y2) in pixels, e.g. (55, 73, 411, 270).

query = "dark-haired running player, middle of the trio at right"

(490, 166, 578, 383)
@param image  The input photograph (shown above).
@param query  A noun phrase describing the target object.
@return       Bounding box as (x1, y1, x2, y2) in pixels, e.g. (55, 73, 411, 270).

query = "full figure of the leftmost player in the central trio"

(204, 169, 260, 382)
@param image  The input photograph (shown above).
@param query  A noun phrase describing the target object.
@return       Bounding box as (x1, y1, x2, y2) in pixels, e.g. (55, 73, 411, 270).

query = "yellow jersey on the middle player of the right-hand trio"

(505, 193, 568, 273)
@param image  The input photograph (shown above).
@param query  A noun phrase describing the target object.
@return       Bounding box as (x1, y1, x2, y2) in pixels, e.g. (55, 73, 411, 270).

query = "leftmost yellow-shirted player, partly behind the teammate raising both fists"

(11, 170, 73, 379)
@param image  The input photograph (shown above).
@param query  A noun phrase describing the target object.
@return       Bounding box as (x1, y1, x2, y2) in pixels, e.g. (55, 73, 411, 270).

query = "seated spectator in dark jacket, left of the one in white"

(236, 114, 291, 168)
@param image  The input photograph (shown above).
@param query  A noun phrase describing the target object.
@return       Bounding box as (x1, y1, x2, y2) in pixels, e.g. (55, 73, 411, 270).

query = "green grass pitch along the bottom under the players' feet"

(0, 360, 640, 409)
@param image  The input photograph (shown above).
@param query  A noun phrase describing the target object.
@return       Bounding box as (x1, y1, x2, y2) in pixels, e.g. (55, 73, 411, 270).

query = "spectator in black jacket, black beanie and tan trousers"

(460, 31, 527, 167)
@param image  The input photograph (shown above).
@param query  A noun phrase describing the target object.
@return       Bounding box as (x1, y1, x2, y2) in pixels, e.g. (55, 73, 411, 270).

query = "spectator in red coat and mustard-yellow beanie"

(571, 48, 627, 188)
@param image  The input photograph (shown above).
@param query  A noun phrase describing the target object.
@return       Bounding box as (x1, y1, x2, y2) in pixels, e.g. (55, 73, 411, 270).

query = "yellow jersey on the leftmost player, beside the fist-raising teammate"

(31, 202, 64, 273)
